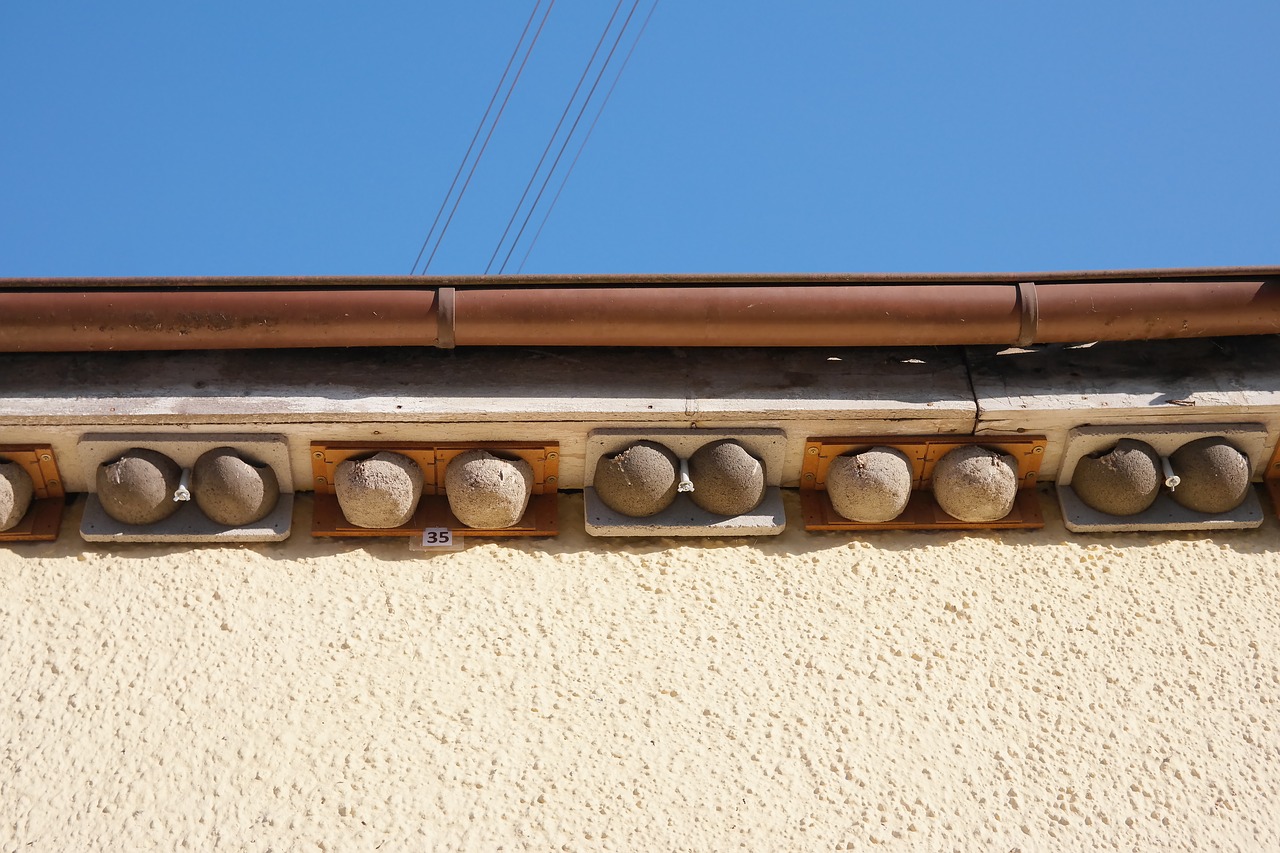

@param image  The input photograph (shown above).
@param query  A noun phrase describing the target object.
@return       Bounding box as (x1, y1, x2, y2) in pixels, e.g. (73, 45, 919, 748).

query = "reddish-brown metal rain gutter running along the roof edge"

(0, 268, 1280, 352)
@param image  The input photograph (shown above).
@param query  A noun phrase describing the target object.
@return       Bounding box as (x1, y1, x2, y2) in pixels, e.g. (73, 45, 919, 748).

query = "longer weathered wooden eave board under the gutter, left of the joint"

(0, 347, 974, 425)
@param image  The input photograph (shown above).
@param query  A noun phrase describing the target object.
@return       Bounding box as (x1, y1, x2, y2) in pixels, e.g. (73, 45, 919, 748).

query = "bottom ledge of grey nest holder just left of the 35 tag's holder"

(81, 493, 293, 544)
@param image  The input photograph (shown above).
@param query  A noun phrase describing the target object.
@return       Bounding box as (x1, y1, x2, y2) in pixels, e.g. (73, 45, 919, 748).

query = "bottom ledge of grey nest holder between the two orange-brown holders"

(582, 485, 787, 537)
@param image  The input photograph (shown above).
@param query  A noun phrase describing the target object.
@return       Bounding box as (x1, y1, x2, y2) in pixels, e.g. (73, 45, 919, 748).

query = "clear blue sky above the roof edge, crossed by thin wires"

(0, 0, 1280, 277)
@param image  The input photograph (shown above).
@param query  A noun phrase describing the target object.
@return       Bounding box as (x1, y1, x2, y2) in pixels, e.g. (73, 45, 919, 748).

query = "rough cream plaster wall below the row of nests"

(0, 493, 1280, 850)
